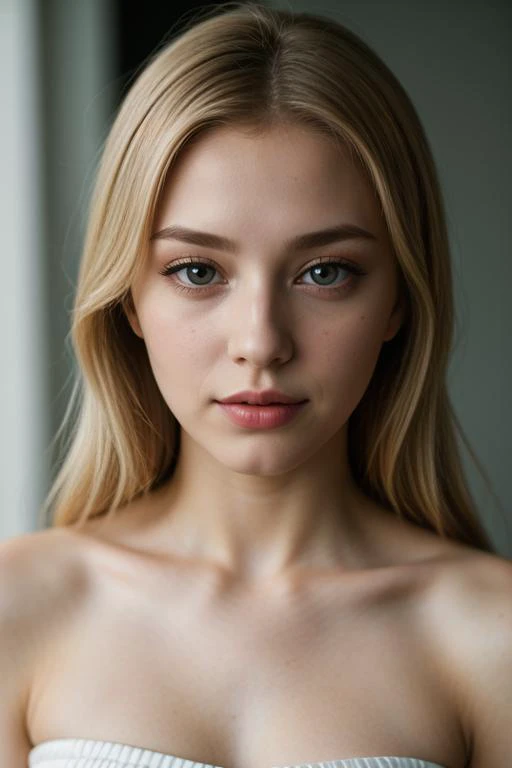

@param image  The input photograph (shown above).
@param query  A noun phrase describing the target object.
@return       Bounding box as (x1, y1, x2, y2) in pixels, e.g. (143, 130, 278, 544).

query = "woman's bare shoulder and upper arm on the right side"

(426, 552, 512, 768)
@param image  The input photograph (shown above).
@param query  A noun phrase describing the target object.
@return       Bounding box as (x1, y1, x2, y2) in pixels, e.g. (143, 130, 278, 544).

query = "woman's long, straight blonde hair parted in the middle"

(43, 3, 494, 552)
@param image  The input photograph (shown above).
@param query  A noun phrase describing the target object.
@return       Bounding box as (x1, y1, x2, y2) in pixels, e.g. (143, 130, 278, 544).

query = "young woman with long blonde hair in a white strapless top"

(0, 5, 512, 768)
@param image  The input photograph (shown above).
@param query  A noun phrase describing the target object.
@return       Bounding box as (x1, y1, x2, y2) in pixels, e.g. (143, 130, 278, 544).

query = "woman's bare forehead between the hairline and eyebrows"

(157, 124, 380, 236)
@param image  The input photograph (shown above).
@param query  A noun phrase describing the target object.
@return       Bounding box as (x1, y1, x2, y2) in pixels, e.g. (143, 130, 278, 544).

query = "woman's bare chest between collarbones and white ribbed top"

(29, 560, 464, 768)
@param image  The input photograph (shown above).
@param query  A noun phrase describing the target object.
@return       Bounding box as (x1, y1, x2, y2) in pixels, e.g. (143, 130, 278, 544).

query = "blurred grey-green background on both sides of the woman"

(0, 0, 512, 558)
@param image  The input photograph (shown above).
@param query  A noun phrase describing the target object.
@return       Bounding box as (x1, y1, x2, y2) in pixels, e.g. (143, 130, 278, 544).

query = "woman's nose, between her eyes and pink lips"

(227, 286, 294, 369)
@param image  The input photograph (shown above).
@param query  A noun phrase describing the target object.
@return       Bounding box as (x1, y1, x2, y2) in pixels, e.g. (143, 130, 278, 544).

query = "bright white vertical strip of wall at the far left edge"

(0, 0, 48, 538)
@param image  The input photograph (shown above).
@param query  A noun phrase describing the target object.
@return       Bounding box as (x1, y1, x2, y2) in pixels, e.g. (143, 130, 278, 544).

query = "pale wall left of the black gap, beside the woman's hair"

(0, 0, 113, 539)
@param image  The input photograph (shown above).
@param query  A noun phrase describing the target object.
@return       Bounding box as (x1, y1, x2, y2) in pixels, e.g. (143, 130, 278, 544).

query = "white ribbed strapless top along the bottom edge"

(28, 739, 445, 768)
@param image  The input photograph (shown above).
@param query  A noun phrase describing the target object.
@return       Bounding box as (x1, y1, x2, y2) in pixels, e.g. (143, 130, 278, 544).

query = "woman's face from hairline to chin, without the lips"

(128, 125, 402, 475)
